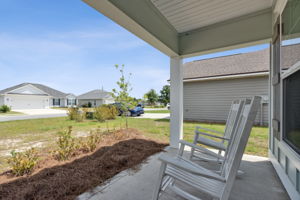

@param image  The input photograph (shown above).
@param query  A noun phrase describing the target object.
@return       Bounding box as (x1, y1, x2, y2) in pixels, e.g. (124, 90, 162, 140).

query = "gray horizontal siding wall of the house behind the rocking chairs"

(183, 76, 268, 125)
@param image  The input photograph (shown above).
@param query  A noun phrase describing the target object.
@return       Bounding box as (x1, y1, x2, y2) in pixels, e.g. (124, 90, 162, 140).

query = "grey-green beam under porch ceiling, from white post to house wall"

(179, 9, 272, 58)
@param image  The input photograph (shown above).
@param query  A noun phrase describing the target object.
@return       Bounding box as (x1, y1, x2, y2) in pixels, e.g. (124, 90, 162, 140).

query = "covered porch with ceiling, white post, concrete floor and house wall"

(84, 0, 300, 199)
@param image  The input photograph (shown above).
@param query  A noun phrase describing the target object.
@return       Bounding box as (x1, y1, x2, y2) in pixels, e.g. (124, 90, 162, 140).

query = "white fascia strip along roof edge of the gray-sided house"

(183, 72, 269, 82)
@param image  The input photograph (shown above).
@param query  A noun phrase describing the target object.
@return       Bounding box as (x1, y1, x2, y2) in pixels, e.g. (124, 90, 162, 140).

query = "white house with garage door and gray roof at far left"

(0, 83, 76, 109)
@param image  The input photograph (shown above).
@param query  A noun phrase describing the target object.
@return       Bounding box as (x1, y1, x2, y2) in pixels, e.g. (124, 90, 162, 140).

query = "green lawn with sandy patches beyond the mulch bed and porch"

(0, 117, 268, 172)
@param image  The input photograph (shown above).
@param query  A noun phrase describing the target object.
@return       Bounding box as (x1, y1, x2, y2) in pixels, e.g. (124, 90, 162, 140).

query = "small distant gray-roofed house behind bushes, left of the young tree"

(77, 90, 115, 107)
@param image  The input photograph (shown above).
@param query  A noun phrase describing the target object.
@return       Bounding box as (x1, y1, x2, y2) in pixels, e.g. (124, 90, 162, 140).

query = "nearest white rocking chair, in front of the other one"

(153, 97, 260, 200)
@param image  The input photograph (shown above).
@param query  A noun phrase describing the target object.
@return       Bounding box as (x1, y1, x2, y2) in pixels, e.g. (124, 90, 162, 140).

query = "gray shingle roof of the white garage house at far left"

(0, 83, 68, 98)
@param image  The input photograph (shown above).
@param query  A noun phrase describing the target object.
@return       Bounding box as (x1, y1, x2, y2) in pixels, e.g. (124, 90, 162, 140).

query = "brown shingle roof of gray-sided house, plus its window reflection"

(183, 44, 300, 80)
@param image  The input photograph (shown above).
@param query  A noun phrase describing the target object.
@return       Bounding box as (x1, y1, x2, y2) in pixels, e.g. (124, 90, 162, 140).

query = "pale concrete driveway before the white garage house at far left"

(0, 109, 67, 122)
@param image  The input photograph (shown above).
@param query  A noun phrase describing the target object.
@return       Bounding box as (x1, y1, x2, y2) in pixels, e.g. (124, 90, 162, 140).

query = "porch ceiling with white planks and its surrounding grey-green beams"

(83, 0, 276, 57)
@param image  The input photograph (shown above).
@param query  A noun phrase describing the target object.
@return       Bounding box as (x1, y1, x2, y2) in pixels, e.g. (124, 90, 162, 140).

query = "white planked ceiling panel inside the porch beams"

(151, 0, 273, 33)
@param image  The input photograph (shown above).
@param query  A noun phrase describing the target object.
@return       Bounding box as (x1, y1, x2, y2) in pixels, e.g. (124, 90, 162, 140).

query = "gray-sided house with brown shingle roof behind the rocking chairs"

(183, 44, 300, 125)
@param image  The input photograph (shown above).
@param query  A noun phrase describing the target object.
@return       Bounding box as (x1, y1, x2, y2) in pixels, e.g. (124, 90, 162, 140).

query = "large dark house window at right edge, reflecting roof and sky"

(281, 0, 300, 154)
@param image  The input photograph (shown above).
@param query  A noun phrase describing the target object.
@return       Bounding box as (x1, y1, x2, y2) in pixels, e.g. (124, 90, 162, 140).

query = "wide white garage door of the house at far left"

(9, 95, 49, 109)
